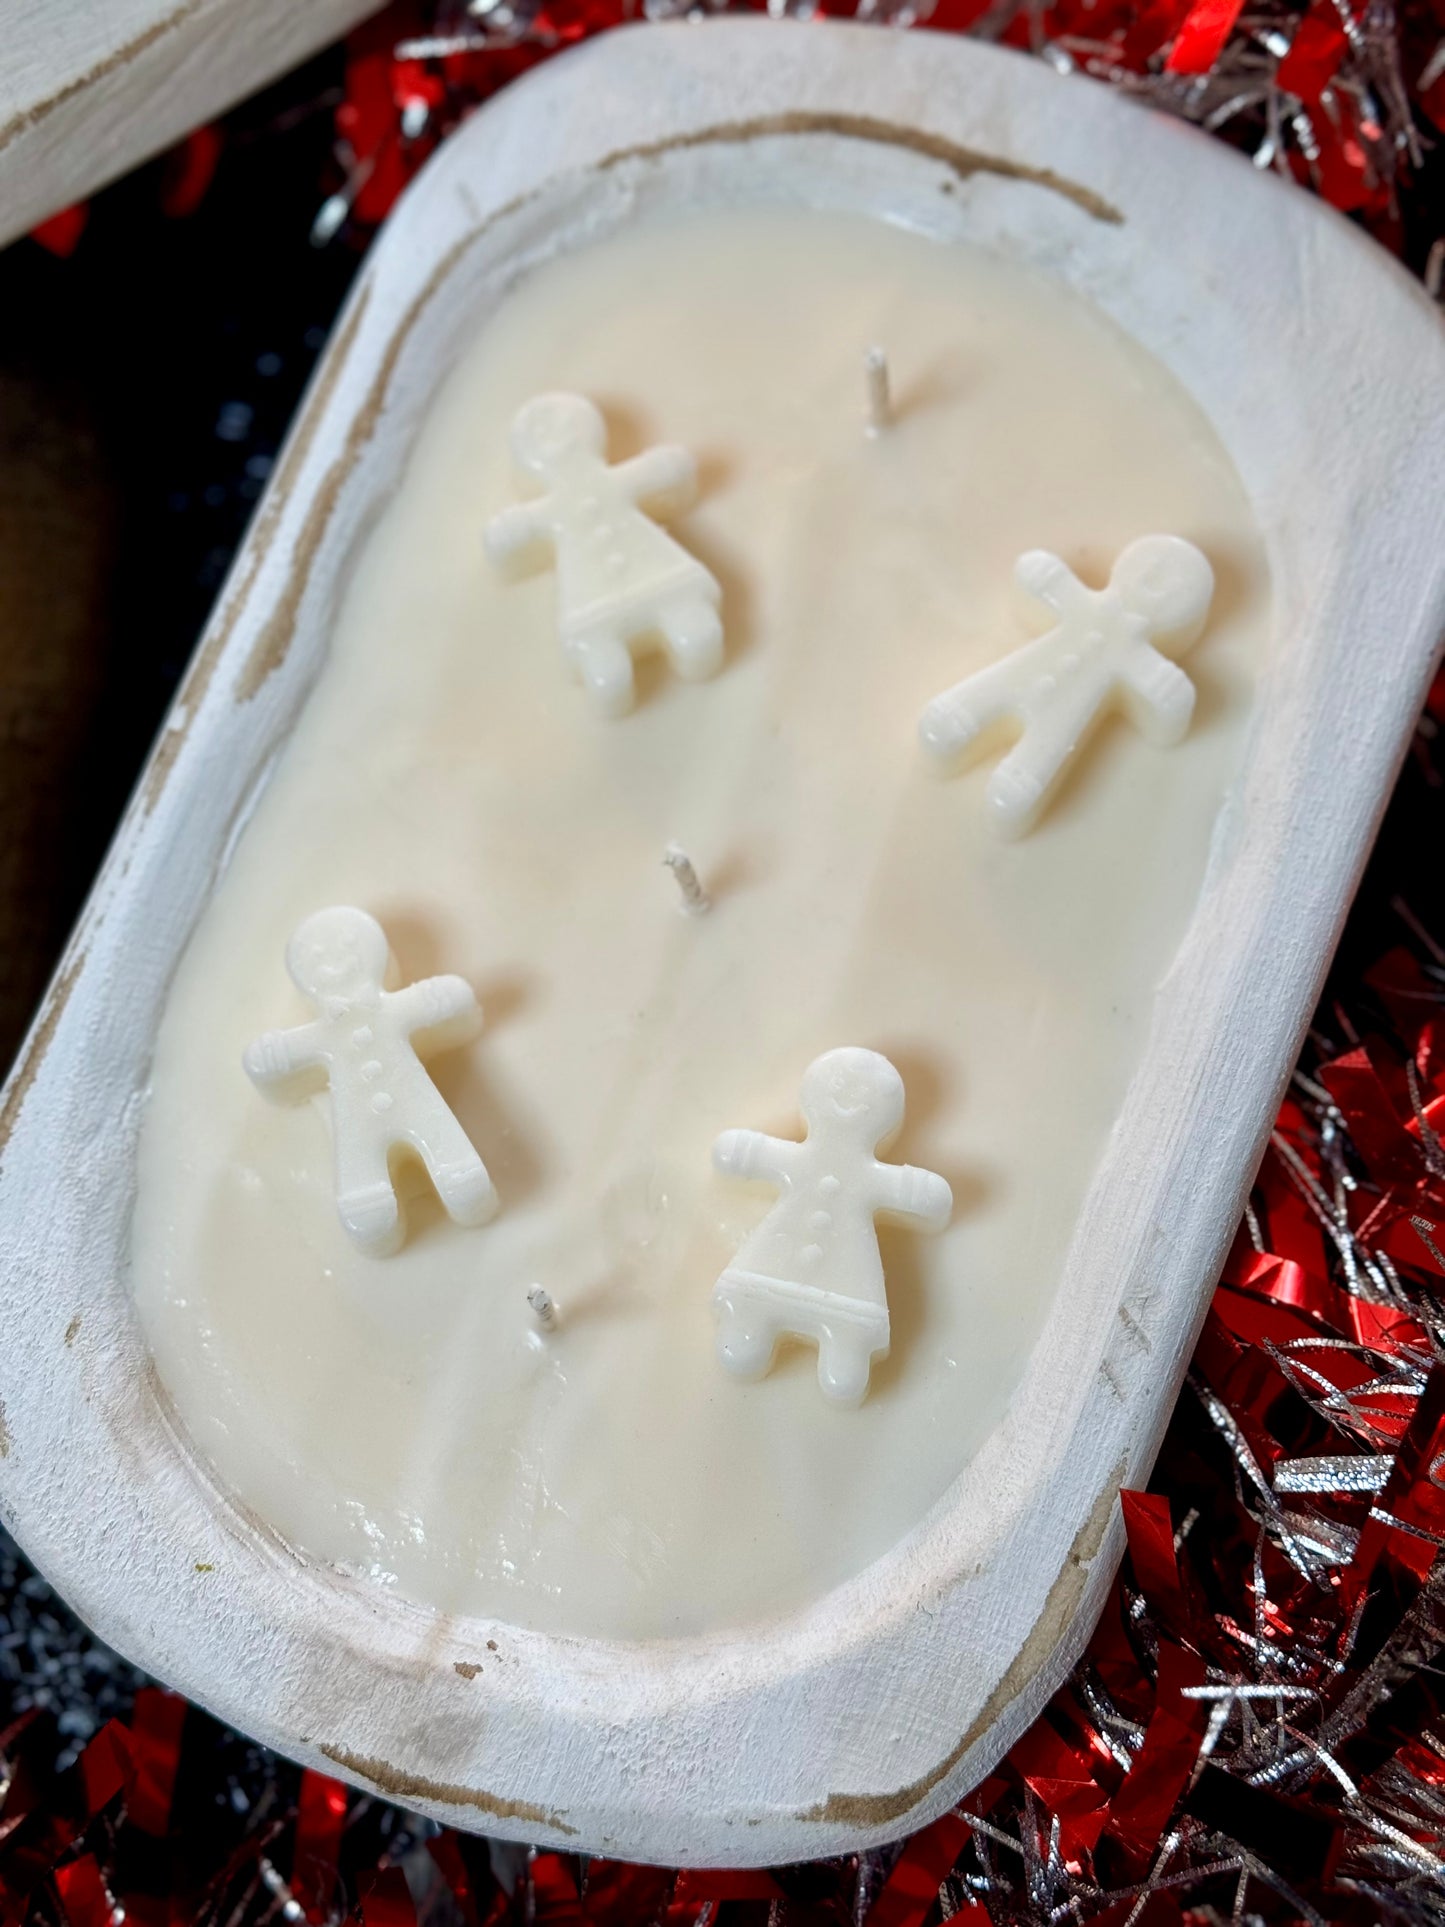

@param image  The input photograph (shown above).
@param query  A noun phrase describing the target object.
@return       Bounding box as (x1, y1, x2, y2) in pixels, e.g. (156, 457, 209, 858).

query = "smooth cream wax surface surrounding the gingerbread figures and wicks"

(133, 208, 1268, 1636)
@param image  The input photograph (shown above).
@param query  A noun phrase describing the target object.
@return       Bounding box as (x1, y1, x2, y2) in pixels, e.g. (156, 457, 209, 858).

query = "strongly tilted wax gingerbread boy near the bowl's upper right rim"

(919, 536, 1214, 836)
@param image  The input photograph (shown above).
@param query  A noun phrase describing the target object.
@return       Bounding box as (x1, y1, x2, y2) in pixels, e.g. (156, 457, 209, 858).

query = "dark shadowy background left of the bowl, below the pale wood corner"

(0, 50, 364, 1071)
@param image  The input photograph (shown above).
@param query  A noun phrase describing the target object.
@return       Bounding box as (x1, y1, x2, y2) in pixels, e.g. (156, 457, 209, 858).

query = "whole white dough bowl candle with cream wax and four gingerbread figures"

(0, 21, 1441, 1865)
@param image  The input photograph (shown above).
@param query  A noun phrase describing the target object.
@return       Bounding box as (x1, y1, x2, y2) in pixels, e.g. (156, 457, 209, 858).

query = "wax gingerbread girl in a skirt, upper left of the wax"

(486, 395, 723, 717)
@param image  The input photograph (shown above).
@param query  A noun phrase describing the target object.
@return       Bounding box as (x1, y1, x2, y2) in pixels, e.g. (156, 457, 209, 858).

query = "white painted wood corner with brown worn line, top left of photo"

(0, 0, 381, 245)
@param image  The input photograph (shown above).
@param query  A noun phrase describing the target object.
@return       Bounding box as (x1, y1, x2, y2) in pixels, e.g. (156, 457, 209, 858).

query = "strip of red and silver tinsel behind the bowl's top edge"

(320, 0, 1445, 260)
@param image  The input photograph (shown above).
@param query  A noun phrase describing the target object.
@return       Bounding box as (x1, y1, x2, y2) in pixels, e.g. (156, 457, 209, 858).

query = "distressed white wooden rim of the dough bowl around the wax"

(0, 19, 1445, 1865)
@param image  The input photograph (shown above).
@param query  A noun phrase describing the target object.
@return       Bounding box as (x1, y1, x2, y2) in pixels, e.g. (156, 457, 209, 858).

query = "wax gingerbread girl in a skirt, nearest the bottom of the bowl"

(713, 1048, 954, 1405)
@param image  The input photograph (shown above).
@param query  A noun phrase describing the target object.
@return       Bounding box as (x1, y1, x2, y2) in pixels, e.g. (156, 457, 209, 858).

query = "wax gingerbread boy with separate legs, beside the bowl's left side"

(243, 906, 497, 1256)
